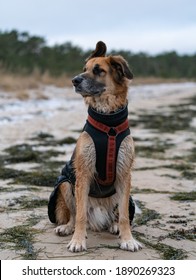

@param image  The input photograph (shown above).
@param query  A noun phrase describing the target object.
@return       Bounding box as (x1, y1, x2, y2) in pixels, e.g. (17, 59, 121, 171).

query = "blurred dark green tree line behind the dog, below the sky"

(0, 30, 196, 78)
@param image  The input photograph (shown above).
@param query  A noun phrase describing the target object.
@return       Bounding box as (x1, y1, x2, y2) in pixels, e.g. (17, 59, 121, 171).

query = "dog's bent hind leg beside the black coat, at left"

(55, 182, 75, 235)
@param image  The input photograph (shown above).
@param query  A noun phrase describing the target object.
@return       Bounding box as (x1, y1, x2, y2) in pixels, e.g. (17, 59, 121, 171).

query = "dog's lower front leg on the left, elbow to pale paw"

(67, 174, 89, 252)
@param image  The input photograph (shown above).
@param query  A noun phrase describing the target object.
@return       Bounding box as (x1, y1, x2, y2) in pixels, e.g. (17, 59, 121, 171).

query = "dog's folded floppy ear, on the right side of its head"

(109, 55, 133, 82)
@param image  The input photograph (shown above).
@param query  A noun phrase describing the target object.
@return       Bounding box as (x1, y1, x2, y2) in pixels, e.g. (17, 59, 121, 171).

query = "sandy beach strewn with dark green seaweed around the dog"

(0, 83, 196, 260)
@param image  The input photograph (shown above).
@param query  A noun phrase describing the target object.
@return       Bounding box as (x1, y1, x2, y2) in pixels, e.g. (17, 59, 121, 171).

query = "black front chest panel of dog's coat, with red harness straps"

(84, 107, 130, 197)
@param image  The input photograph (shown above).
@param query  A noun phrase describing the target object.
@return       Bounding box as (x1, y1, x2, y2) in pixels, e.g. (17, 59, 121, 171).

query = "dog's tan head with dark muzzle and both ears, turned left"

(72, 41, 133, 97)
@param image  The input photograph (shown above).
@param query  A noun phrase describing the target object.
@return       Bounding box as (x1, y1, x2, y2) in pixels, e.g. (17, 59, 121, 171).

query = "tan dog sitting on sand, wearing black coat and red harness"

(48, 41, 142, 252)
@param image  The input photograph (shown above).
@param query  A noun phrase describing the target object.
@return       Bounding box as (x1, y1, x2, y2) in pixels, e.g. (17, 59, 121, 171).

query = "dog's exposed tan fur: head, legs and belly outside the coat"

(55, 41, 141, 252)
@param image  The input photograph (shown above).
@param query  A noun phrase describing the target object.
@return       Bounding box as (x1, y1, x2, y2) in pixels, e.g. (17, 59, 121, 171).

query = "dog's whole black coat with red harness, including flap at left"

(48, 106, 133, 223)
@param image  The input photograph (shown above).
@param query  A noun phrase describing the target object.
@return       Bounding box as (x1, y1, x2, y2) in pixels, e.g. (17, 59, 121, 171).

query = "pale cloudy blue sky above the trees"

(0, 0, 196, 55)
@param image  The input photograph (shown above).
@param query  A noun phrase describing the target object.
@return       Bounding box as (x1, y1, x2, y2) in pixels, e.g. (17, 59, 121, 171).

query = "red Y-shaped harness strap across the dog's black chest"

(88, 115, 129, 186)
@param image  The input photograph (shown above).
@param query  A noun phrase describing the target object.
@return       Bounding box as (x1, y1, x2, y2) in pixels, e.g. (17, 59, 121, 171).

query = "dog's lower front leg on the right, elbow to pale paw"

(119, 175, 142, 251)
